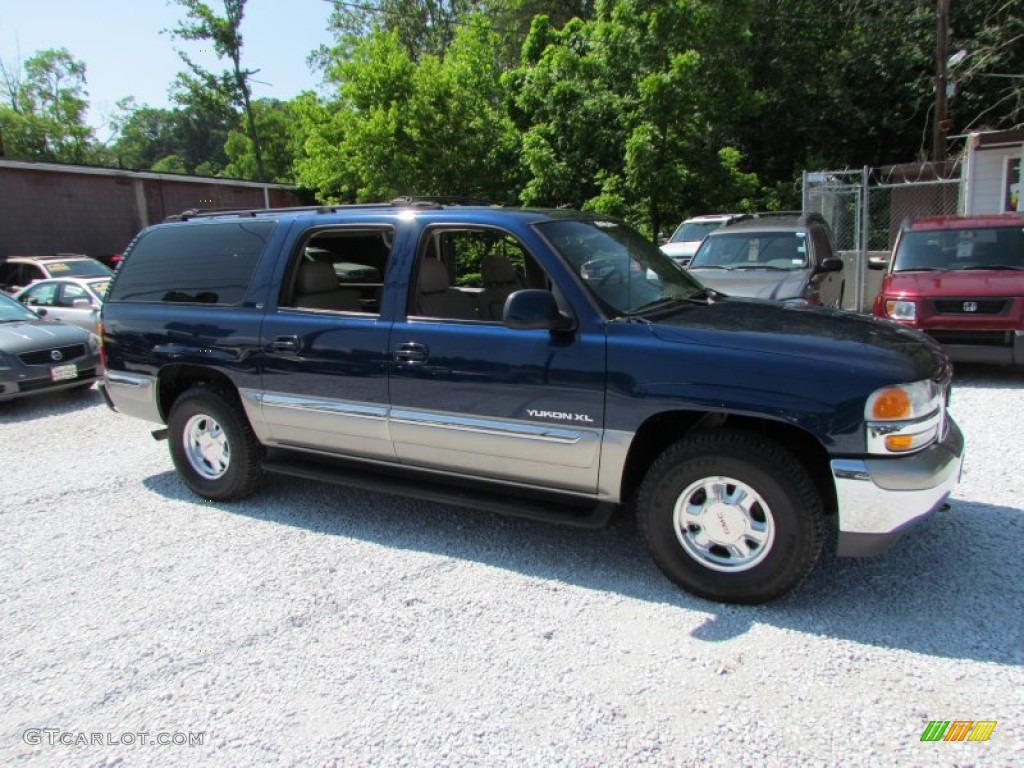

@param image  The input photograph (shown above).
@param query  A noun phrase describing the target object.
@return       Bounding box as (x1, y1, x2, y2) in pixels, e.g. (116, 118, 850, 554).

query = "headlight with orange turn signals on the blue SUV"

(864, 381, 944, 454)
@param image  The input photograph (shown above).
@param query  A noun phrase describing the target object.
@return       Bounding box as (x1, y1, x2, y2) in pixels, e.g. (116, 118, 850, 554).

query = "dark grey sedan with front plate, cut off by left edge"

(0, 295, 102, 400)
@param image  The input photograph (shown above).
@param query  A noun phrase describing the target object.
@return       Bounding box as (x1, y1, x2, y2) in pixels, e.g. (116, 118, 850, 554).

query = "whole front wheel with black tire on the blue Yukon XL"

(637, 430, 825, 604)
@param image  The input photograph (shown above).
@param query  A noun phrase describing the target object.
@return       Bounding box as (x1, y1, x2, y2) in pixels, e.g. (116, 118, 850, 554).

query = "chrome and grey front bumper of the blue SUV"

(831, 416, 964, 557)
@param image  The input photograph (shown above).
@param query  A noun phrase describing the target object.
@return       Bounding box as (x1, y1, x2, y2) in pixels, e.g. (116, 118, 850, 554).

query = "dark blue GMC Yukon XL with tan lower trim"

(101, 202, 964, 603)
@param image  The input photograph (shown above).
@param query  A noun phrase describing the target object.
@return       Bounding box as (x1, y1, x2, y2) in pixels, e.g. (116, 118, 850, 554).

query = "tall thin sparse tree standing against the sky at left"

(170, 0, 265, 181)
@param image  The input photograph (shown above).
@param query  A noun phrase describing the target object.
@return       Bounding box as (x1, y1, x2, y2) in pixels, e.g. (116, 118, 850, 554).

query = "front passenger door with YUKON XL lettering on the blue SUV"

(388, 224, 605, 494)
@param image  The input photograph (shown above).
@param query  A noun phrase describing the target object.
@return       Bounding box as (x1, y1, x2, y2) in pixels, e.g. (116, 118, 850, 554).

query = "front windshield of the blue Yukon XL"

(537, 220, 706, 314)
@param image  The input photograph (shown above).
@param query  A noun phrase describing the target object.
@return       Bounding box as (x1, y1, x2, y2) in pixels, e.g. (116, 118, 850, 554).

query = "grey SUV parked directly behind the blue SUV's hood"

(687, 213, 846, 308)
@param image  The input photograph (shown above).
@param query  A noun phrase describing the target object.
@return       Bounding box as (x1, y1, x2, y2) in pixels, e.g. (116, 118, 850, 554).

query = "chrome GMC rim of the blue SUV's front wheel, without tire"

(672, 475, 775, 573)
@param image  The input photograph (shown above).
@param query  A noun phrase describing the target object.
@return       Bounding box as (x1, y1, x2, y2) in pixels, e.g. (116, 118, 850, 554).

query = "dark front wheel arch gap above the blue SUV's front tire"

(620, 411, 838, 516)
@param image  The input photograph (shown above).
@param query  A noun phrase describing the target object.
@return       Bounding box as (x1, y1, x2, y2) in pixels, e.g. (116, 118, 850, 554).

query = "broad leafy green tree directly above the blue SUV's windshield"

(506, 0, 756, 233)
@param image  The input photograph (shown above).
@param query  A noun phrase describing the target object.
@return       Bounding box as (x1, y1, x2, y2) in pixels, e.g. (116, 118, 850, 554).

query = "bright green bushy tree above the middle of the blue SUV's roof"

(296, 24, 518, 202)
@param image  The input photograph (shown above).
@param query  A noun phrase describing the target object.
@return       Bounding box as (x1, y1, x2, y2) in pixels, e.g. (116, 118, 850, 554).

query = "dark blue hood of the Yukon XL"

(652, 298, 948, 383)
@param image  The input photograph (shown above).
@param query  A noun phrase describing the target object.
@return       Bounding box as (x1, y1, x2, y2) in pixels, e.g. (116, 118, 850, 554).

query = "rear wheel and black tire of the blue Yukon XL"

(167, 387, 263, 502)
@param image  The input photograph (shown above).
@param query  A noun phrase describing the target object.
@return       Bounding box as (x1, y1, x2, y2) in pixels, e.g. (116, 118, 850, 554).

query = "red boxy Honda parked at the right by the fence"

(874, 213, 1024, 366)
